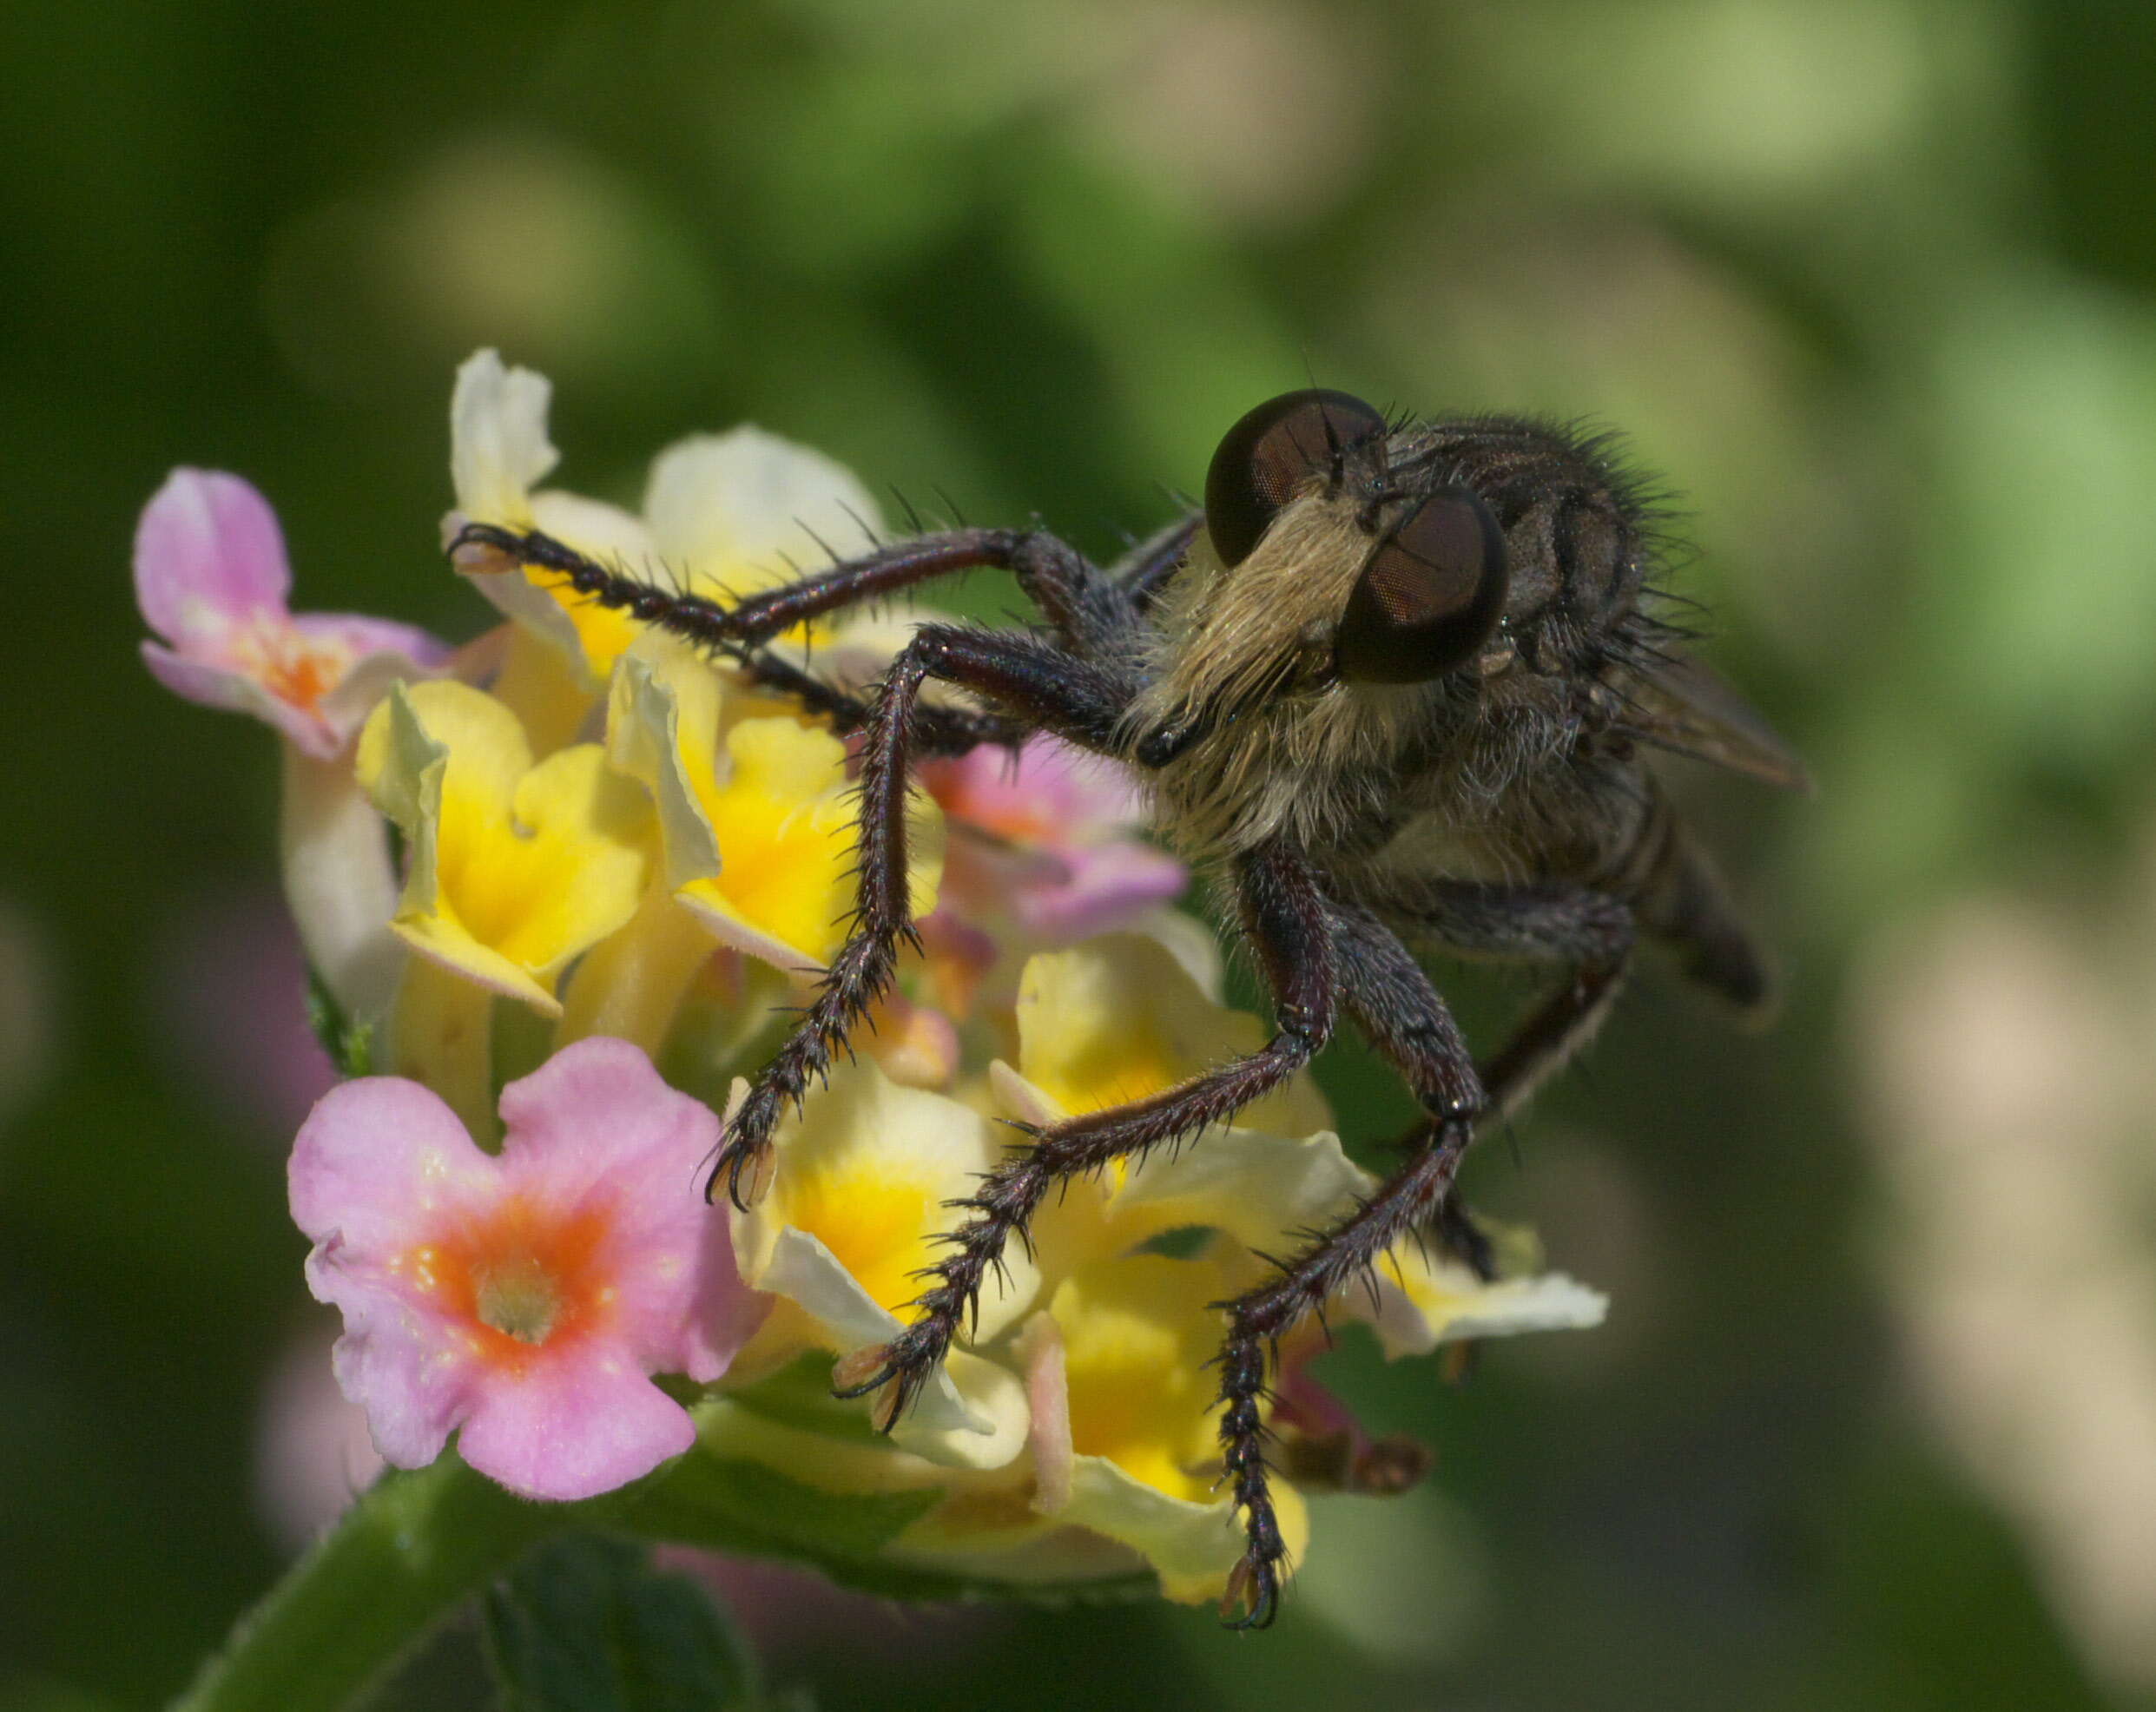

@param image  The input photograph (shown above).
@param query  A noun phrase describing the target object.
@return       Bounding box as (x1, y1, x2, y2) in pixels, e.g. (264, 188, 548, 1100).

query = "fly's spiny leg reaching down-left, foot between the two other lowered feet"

(834, 852, 1335, 1430)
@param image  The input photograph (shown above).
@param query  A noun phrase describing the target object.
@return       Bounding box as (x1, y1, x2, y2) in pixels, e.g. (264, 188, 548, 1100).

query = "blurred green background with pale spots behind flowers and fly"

(0, 0, 2156, 1712)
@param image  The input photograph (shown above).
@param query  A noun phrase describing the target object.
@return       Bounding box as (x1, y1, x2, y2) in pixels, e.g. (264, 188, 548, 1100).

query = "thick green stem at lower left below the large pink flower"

(173, 1453, 597, 1712)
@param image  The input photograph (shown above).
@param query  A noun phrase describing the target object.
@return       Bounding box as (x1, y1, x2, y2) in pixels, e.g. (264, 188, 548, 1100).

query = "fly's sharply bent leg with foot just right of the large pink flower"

(705, 625, 1130, 1208)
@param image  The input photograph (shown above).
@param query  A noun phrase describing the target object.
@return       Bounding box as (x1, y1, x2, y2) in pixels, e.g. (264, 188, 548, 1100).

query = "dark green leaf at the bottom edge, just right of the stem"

(485, 1533, 763, 1712)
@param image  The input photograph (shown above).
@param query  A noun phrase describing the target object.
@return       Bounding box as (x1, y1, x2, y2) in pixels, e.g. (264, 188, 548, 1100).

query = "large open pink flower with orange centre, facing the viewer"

(291, 1037, 765, 1498)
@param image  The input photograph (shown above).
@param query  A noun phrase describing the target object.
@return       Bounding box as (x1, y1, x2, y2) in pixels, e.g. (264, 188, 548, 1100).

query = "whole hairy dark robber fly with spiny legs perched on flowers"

(452, 388, 1803, 1623)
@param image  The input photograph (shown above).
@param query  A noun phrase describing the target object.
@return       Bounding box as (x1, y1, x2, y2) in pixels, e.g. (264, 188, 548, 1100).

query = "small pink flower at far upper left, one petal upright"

(135, 470, 448, 759)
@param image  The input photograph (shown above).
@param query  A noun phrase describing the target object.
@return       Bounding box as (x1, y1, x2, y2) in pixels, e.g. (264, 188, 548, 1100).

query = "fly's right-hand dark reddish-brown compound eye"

(1332, 487, 1505, 683)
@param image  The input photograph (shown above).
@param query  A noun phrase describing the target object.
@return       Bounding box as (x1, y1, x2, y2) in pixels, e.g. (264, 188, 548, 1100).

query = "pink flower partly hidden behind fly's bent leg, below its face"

(920, 737, 1188, 945)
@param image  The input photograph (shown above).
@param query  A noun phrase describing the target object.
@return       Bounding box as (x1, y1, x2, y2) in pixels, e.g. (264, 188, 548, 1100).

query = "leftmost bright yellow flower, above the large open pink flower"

(358, 682, 651, 1016)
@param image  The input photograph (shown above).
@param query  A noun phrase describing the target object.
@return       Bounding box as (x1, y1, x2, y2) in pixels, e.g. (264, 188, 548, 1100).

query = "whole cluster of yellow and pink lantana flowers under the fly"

(135, 352, 1602, 1600)
